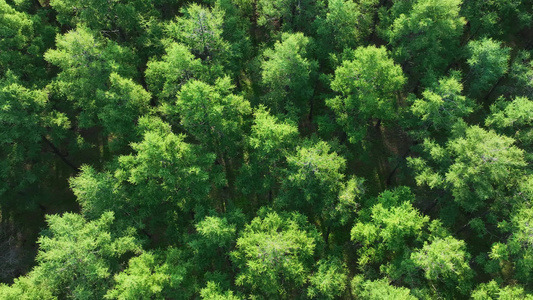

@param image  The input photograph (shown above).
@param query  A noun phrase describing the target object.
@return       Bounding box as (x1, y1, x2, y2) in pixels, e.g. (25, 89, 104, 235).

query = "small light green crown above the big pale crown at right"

(411, 76, 474, 131)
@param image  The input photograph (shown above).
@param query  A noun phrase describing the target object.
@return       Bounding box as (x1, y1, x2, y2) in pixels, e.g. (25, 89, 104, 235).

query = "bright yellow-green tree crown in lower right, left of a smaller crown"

(351, 187, 429, 271)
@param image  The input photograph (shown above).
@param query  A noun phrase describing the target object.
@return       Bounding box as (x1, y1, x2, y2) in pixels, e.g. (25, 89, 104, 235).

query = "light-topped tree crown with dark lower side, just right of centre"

(274, 140, 346, 221)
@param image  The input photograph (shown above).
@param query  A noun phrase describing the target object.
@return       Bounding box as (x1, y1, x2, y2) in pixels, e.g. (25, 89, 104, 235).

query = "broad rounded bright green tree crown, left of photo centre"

(115, 120, 218, 213)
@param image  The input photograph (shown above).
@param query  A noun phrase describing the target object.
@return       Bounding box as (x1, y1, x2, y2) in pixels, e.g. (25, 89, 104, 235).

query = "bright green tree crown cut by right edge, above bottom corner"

(489, 206, 533, 285)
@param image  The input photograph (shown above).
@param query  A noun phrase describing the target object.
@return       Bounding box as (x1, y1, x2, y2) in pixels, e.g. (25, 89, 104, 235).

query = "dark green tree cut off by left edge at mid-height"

(0, 76, 70, 200)
